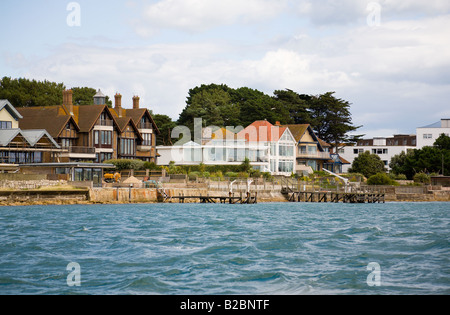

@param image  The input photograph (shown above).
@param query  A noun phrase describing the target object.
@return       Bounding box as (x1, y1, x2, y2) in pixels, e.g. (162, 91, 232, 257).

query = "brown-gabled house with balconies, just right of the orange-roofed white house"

(284, 124, 332, 175)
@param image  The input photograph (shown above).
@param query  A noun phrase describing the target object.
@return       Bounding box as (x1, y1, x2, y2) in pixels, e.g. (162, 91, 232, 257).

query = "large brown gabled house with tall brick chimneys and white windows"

(18, 90, 159, 163)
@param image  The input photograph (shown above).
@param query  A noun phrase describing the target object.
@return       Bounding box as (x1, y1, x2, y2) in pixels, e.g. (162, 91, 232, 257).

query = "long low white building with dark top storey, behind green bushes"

(339, 135, 416, 172)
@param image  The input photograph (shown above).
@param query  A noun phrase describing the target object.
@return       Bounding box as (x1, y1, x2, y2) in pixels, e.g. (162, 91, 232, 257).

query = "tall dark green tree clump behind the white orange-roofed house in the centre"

(177, 84, 362, 147)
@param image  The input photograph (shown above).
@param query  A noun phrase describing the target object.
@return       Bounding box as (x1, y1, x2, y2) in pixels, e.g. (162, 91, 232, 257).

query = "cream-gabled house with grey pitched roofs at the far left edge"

(0, 100, 63, 169)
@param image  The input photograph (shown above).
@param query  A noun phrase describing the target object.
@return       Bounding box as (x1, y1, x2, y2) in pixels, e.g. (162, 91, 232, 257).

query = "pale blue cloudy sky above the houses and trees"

(0, 0, 450, 138)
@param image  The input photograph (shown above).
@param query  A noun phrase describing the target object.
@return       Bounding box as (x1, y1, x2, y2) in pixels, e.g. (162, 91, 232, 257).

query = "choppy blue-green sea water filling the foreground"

(0, 203, 450, 295)
